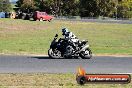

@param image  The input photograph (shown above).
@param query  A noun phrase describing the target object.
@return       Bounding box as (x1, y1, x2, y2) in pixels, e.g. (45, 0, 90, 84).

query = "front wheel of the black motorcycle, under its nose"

(48, 49, 61, 59)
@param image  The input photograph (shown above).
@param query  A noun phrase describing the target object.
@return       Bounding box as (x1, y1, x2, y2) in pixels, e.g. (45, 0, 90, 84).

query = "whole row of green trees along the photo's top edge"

(0, 0, 132, 18)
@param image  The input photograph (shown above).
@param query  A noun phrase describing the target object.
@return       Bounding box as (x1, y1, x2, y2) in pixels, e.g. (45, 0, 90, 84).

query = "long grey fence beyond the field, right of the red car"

(55, 16, 132, 24)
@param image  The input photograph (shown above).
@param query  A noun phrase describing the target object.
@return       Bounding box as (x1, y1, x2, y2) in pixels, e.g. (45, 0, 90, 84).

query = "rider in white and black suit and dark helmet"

(62, 28, 79, 49)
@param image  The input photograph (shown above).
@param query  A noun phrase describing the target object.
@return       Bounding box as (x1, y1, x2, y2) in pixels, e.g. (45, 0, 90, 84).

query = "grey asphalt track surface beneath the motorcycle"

(0, 55, 132, 74)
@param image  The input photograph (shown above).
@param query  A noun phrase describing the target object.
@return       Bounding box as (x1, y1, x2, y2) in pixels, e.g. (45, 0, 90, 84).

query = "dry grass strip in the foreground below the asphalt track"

(0, 73, 132, 88)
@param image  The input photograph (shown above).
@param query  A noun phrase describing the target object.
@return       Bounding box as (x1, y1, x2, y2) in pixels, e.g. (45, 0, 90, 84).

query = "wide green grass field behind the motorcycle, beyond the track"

(0, 19, 132, 55)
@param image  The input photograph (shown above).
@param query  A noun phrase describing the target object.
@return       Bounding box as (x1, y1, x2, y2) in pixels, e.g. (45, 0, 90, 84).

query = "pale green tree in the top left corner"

(0, 0, 12, 12)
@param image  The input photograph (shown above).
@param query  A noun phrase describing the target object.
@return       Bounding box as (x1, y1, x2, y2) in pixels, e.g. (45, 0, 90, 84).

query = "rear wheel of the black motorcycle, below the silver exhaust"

(80, 48, 92, 59)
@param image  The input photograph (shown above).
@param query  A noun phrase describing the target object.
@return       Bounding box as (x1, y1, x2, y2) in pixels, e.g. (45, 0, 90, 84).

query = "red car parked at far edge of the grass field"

(33, 11, 54, 22)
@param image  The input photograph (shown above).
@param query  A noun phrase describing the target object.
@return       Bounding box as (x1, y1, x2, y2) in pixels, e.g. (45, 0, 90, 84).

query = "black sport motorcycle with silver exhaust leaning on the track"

(48, 34, 92, 59)
